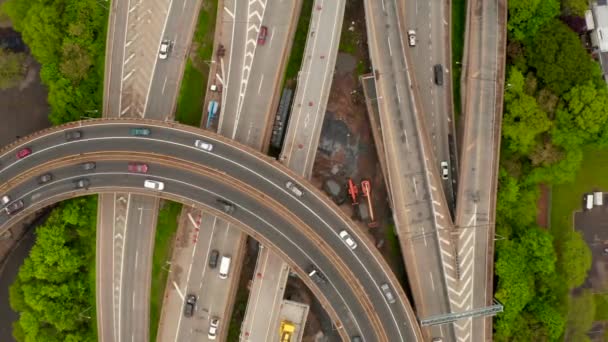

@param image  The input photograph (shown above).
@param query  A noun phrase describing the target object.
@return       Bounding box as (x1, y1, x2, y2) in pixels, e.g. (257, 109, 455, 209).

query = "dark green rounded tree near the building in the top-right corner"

(524, 19, 605, 95)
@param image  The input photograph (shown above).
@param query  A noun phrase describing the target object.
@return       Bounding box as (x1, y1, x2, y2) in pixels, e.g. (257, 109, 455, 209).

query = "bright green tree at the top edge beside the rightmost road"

(507, 0, 559, 40)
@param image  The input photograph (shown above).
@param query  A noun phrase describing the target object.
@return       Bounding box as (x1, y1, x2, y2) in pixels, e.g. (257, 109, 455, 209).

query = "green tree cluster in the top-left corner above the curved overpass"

(2, 0, 108, 124)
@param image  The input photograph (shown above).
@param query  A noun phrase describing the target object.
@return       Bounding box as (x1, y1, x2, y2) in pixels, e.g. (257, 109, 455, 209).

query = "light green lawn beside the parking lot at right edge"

(550, 148, 608, 241)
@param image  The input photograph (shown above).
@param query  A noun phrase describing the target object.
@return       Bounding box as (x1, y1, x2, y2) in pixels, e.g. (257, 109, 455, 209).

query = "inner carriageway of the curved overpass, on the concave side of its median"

(2, 170, 376, 341)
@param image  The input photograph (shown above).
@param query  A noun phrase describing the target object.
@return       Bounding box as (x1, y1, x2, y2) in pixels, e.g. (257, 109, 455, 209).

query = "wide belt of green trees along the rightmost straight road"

(494, 0, 608, 341)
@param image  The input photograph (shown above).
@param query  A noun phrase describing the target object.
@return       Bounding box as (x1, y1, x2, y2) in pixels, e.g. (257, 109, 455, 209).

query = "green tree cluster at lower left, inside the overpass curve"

(9, 196, 97, 342)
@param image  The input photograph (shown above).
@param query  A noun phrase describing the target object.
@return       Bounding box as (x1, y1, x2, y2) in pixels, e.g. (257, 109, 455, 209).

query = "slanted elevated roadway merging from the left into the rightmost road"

(364, 0, 457, 341)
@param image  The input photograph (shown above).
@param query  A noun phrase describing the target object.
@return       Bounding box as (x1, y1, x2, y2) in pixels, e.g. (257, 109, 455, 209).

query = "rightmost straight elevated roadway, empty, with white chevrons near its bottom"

(454, 0, 507, 341)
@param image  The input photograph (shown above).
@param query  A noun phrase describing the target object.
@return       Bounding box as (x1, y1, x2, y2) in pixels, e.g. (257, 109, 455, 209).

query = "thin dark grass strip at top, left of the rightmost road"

(452, 0, 467, 120)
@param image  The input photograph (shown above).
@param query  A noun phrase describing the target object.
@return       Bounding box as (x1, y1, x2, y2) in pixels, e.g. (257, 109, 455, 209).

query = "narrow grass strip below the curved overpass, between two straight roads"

(150, 201, 182, 341)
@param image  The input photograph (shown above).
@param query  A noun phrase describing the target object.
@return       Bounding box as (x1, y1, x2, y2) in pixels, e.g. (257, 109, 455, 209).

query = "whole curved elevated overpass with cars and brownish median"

(0, 120, 421, 341)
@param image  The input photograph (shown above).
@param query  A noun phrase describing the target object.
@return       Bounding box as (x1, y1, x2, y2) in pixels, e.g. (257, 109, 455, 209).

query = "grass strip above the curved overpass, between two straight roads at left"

(175, 0, 218, 127)
